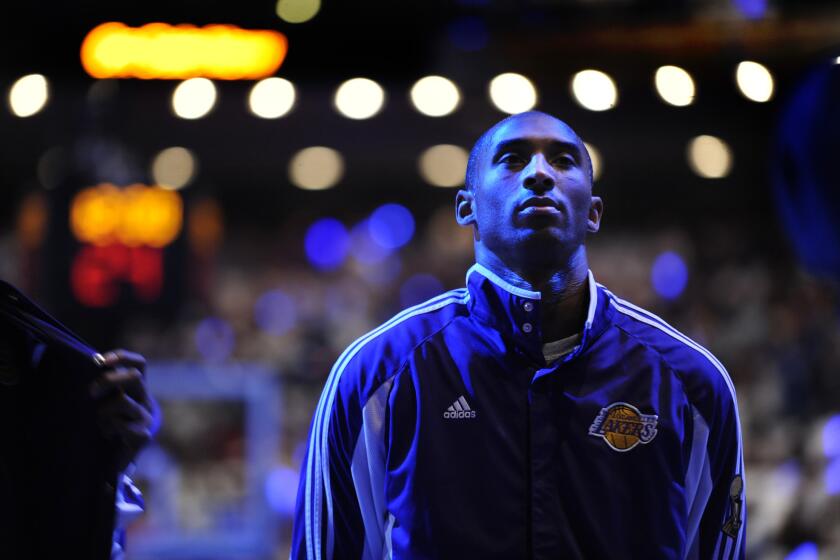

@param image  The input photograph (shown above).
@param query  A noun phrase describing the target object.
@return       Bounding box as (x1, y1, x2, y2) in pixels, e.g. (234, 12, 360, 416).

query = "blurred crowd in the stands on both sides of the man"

(4, 196, 840, 560)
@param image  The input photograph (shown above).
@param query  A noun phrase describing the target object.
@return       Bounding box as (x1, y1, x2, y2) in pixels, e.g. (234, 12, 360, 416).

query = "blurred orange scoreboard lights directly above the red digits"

(70, 183, 184, 248)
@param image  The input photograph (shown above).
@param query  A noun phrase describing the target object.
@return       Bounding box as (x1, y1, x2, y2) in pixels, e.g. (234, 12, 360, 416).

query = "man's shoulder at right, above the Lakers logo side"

(605, 290, 734, 398)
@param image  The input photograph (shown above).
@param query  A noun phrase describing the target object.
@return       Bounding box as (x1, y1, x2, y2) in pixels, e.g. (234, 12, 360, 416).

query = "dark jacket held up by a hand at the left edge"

(0, 281, 123, 560)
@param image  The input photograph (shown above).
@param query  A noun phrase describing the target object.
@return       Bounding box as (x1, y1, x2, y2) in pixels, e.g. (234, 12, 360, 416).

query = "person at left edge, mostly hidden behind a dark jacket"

(0, 281, 159, 559)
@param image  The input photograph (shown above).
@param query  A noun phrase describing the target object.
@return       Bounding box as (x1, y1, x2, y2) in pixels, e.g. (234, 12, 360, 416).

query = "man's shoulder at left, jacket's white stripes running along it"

(335, 288, 468, 375)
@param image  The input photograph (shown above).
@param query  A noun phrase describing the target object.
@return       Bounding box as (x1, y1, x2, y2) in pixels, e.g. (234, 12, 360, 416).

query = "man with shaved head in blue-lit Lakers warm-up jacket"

(292, 112, 745, 560)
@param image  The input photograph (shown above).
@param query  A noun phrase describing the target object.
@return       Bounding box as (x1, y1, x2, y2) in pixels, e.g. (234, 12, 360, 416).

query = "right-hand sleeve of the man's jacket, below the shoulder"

(686, 367, 747, 560)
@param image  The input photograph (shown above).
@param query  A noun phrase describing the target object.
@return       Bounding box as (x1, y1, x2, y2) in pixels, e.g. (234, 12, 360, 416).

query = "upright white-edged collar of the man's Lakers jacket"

(466, 263, 609, 361)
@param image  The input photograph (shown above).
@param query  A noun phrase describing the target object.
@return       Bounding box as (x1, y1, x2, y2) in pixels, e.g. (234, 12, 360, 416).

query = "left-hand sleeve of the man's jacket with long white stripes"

(290, 358, 378, 560)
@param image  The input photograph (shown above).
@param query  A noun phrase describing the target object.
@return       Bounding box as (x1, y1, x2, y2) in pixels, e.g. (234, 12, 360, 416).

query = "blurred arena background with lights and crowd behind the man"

(0, 0, 840, 560)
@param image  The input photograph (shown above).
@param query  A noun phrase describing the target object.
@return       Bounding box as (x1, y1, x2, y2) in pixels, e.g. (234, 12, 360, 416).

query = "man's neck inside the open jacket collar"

(476, 246, 589, 342)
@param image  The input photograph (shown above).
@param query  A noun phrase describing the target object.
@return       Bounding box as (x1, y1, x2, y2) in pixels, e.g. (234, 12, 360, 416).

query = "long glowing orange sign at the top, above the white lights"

(81, 22, 288, 80)
